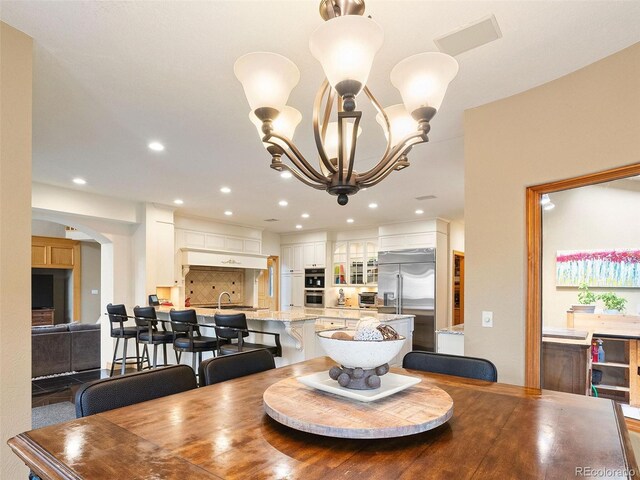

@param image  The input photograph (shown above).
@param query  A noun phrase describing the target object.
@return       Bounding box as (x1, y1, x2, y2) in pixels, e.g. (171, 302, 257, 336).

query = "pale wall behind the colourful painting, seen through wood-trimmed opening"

(542, 180, 640, 327)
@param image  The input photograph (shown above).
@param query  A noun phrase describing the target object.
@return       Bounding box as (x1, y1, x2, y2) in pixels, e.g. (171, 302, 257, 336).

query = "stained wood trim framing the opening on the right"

(525, 163, 640, 388)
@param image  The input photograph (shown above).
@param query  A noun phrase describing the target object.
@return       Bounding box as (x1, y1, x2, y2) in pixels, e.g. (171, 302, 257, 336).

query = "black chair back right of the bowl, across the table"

(402, 351, 498, 382)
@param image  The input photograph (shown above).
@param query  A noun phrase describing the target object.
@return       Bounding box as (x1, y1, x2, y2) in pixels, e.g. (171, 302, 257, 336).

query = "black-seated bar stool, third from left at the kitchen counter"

(169, 309, 218, 373)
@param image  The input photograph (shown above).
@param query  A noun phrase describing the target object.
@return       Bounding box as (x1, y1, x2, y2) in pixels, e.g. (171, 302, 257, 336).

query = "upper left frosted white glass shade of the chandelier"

(233, 52, 300, 112)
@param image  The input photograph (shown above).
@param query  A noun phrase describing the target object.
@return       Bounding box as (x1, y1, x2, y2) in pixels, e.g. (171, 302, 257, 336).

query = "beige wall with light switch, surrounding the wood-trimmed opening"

(464, 44, 640, 384)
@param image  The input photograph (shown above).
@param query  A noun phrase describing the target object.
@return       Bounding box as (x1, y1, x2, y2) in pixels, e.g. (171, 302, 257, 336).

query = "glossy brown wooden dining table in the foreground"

(8, 357, 638, 480)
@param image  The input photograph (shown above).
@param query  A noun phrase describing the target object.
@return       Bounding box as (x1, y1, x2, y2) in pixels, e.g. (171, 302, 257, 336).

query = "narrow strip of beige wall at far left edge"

(0, 22, 33, 479)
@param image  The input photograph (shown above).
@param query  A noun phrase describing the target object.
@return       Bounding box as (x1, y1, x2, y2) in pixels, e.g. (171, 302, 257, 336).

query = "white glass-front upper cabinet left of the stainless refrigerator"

(333, 241, 378, 286)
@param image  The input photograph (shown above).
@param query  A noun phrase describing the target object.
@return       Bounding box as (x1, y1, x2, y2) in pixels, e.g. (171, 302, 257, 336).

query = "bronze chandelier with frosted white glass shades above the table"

(233, 0, 458, 205)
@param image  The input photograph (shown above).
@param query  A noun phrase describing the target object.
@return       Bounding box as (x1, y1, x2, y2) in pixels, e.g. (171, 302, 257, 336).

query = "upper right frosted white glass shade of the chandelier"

(391, 52, 458, 113)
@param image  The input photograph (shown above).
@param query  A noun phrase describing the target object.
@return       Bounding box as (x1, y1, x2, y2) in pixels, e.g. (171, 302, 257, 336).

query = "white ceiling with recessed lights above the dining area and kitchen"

(0, 0, 640, 232)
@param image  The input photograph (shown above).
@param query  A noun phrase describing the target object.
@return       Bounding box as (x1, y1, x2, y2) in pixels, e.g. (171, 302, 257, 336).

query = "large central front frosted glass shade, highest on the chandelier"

(309, 15, 384, 96)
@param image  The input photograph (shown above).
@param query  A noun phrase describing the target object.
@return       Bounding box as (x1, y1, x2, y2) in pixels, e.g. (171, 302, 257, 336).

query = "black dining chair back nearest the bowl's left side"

(199, 349, 276, 386)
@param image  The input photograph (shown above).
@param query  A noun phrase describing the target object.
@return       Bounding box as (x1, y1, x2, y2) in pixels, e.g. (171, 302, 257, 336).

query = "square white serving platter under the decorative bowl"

(297, 371, 422, 402)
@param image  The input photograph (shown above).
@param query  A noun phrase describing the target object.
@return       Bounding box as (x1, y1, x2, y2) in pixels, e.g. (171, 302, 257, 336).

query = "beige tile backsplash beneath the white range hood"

(184, 267, 244, 305)
